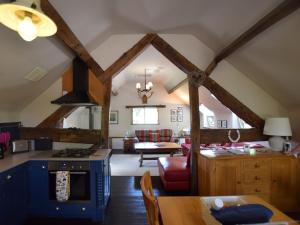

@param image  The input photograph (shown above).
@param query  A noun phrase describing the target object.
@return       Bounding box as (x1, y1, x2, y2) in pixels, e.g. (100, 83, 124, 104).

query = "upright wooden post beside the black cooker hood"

(100, 77, 112, 148)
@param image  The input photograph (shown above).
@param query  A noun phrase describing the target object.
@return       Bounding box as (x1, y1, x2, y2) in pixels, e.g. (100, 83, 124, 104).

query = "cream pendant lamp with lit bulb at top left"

(0, 0, 57, 41)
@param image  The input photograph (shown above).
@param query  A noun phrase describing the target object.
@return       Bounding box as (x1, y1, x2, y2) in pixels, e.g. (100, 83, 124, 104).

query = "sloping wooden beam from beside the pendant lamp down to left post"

(41, 0, 103, 79)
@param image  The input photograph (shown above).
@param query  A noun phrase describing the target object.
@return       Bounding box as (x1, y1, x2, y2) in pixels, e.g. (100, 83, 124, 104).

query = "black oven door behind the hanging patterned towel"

(49, 171, 91, 201)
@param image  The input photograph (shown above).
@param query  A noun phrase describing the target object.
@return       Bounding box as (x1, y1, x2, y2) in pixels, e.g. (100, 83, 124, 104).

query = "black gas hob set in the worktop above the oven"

(52, 148, 96, 158)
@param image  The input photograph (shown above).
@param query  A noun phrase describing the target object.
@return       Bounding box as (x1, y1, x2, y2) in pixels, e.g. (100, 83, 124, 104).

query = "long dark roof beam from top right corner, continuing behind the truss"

(168, 0, 300, 94)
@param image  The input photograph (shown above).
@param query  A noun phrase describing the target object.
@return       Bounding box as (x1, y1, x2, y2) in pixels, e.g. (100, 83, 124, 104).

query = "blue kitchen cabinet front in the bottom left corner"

(0, 163, 28, 225)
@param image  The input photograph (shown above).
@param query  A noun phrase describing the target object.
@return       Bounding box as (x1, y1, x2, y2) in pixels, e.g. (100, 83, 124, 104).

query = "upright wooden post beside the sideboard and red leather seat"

(188, 79, 200, 195)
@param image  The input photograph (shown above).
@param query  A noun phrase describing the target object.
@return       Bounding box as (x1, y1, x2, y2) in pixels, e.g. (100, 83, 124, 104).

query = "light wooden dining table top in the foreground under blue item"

(157, 195, 298, 225)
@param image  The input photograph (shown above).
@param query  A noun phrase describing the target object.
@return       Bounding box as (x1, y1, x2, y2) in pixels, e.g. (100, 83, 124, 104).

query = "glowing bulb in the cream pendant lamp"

(18, 16, 37, 41)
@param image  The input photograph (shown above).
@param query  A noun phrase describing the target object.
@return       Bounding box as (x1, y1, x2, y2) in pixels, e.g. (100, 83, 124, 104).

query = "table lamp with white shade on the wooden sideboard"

(264, 117, 292, 151)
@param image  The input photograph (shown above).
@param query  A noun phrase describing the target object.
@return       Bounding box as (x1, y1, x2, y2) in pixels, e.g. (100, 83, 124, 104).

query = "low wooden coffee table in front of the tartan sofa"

(134, 142, 181, 167)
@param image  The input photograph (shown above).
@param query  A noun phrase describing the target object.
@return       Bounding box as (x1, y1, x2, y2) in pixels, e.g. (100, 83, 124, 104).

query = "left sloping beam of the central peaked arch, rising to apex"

(103, 33, 156, 81)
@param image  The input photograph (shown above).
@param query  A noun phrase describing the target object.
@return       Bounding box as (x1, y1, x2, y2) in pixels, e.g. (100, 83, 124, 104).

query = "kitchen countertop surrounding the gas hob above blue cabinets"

(0, 149, 111, 173)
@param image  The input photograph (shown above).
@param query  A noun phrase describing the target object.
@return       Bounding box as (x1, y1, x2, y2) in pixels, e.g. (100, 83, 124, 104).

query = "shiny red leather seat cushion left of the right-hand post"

(158, 156, 190, 181)
